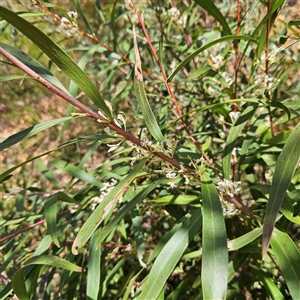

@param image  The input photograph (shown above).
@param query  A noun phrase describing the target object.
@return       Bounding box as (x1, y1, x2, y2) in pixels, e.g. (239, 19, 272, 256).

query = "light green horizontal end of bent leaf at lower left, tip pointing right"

(25, 255, 83, 272)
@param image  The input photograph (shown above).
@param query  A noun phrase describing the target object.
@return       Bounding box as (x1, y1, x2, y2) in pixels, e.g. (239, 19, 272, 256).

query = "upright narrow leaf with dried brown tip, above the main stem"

(133, 27, 164, 142)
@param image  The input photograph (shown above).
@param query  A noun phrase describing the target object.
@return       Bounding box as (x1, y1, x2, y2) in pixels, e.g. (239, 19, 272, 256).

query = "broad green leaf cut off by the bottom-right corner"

(271, 228, 300, 299)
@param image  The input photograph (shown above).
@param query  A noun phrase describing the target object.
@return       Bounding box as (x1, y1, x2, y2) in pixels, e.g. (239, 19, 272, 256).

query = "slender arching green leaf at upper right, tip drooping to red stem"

(168, 35, 256, 82)
